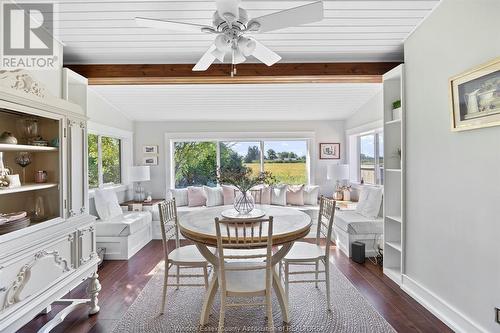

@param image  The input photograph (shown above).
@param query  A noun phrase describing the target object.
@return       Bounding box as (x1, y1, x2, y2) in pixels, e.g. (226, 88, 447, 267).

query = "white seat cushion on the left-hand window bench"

(95, 212, 152, 237)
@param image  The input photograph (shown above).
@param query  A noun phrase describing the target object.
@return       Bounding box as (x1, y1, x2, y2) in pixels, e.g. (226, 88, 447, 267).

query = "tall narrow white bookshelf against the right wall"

(383, 64, 405, 285)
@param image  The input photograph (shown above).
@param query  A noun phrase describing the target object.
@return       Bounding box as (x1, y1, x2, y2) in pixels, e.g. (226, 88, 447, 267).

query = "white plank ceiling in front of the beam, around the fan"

(42, 0, 439, 64)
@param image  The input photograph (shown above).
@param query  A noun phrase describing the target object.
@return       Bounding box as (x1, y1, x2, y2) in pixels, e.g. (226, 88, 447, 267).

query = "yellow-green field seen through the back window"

(245, 161, 307, 184)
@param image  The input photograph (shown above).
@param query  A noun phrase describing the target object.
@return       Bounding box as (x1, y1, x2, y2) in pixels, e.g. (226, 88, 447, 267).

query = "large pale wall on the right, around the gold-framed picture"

(405, 0, 500, 332)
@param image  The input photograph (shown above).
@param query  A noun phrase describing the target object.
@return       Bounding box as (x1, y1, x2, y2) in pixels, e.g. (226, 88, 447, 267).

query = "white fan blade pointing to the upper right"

(248, 1, 324, 32)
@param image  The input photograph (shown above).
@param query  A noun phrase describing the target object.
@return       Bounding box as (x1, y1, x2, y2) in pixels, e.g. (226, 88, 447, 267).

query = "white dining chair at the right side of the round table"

(280, 196, 335, 311)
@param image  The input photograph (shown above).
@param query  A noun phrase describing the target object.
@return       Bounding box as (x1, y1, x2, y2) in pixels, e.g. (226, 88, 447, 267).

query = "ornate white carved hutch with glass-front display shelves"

(0, 70, 100, 333)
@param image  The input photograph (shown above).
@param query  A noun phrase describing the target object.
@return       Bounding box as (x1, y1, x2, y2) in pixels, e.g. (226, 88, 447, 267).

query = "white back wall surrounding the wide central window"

(134, 121, 345, 197)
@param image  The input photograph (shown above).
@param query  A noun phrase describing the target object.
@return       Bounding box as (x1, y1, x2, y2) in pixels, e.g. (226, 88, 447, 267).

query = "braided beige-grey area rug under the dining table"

(113, 262, 396, 333)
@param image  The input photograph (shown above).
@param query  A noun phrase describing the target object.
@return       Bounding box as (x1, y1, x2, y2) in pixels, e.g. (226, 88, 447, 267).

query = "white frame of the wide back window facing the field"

(165, 132, 315, 190)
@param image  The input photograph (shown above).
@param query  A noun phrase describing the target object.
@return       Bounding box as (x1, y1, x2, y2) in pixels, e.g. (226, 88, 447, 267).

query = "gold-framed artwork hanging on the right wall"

(449, 58, 500, 131)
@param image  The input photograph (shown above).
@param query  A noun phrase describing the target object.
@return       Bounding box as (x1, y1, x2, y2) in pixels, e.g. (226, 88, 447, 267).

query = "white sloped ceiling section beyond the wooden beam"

(91, 83, 382, 121)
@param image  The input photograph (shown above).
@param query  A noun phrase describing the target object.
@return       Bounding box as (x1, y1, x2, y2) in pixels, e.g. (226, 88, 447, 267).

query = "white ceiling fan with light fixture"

(135, 0, 323, 71)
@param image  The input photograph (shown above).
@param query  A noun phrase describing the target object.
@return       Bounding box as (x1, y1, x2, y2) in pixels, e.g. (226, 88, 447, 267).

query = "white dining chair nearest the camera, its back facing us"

(215, 216, 274, 332)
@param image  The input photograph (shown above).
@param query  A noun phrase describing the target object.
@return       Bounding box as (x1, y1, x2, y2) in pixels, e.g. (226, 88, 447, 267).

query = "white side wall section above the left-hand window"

(87, 87, 133, 131)
